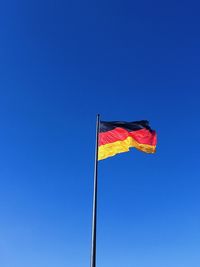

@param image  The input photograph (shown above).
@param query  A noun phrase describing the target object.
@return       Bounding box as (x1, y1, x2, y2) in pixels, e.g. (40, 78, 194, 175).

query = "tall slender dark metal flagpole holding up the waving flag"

(90, 114, 100, 267)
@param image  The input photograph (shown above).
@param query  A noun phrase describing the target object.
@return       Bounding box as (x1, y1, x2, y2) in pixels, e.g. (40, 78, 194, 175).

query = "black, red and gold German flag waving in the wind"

(98, 120, 157, 160)
